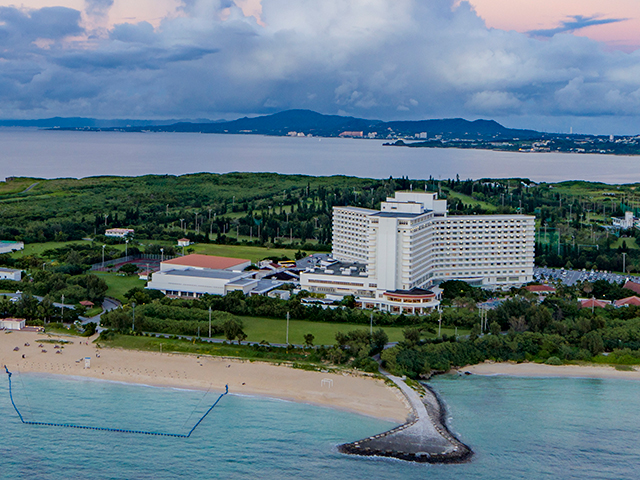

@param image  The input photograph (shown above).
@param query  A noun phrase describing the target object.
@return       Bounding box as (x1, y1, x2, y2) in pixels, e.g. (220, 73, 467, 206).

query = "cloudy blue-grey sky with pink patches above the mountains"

(0, 0, 640, 134)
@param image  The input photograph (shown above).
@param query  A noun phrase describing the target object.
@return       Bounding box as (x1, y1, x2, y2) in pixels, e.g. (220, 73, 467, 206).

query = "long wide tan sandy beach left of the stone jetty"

(0, 331, 410, 423)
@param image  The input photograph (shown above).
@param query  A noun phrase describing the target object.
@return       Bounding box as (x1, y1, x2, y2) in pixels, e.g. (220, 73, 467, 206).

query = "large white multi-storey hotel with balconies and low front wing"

(300, 192, 535, 313)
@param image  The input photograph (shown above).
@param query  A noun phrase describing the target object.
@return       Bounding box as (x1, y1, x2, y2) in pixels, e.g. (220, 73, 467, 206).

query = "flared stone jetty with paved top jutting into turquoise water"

(338, 375, 473, 463)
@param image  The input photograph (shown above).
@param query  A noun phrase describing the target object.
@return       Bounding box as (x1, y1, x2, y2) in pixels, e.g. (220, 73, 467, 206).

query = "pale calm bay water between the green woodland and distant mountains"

(0, 128, 640, 183)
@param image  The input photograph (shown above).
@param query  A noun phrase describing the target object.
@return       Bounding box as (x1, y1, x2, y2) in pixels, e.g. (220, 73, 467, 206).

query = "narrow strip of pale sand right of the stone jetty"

(459, 362, 640, 380)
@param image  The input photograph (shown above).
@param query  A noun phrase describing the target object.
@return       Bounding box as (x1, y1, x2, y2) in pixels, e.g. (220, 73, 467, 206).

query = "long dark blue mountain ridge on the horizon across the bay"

(119, 110, 543, 140)
